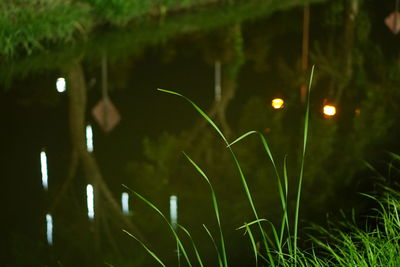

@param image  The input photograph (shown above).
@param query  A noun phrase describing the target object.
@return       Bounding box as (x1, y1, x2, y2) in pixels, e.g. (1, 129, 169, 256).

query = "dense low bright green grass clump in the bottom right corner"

(312, 188, 400, 267)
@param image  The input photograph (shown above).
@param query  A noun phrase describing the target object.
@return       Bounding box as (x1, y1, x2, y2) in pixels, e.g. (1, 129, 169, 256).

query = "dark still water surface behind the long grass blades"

(0, 1, 400, 266)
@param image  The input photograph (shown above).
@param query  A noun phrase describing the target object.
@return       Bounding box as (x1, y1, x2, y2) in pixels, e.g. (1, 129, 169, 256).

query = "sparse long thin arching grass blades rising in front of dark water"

(120, 65, 314, 267)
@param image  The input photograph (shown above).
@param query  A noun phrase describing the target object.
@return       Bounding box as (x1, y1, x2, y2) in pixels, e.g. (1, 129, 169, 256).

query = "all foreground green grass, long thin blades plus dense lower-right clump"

(122, 67, 400, 267)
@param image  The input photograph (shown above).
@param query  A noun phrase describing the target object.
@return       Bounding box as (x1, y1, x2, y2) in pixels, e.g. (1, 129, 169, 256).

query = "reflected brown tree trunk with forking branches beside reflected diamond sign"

(51, 60, 144, 254)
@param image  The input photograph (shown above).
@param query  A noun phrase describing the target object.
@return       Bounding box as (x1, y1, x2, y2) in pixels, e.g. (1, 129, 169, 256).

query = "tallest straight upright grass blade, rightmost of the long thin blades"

(293, 66, 314, 263)
